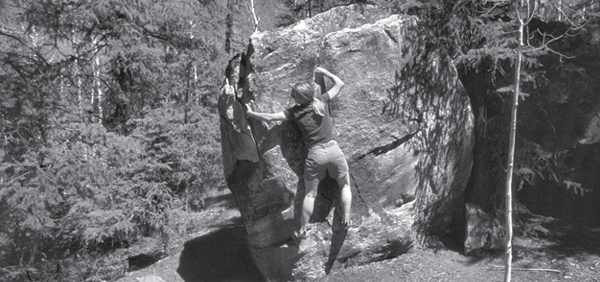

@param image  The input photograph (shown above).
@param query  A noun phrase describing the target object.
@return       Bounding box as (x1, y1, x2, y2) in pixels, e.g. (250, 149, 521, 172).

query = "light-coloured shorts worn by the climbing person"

(304, 140, 348, 181)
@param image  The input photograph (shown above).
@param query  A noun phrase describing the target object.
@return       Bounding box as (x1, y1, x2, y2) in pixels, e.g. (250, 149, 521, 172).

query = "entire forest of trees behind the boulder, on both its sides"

(0, 0, 600, 281)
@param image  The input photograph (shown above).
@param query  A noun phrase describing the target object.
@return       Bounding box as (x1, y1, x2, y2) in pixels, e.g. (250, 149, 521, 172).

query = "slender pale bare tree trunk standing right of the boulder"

(504, 0, 525, 282)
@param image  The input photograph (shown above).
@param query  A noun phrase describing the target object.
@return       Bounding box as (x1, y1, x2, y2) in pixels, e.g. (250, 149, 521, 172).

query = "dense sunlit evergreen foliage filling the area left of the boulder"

(0, 0, 226, 281)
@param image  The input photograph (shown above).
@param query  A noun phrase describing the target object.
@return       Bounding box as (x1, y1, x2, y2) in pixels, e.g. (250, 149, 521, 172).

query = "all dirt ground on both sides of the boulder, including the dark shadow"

(118, 193, 600, 282)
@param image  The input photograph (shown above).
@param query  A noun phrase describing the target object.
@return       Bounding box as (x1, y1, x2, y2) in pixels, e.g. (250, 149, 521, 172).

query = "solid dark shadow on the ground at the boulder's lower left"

(177, 224, 264, 282)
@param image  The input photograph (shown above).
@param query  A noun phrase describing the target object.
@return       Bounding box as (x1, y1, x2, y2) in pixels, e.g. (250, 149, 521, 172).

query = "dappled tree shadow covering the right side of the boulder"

(392, 24, 474, 249)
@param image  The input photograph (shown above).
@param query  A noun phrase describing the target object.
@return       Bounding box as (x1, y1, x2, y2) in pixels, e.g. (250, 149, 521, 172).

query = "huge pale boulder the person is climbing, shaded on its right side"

(219, 5, 473, 281)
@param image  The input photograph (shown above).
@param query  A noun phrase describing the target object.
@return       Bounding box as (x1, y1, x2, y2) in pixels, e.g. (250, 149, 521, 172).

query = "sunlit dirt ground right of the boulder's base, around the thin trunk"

(319, 240, 600, 282)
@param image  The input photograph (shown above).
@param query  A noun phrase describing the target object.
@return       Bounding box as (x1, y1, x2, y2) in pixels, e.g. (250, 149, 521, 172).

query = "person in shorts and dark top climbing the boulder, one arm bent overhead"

(246, 67, 352, 240)
